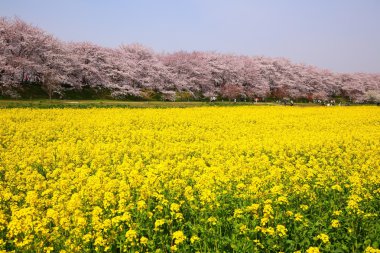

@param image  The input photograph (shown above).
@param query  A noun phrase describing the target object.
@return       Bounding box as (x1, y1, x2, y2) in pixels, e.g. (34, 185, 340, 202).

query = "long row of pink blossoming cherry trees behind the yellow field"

(0, 18, 380, 102)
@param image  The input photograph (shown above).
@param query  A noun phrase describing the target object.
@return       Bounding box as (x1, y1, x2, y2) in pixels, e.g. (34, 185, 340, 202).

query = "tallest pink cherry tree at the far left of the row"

(0, 18, 78, 98)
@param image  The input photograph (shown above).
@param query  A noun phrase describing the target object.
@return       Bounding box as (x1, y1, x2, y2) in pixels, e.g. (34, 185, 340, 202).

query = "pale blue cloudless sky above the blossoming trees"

(0, 0, 380, 73)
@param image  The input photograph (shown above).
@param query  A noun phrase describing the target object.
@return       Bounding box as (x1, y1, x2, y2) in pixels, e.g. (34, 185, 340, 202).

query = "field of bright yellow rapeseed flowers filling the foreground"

(0, 107, 380, 253)
